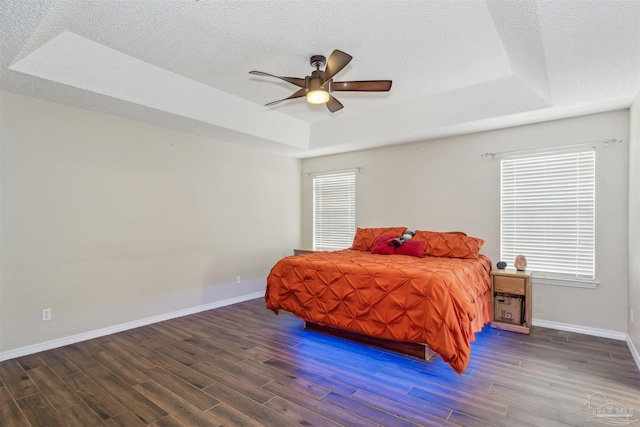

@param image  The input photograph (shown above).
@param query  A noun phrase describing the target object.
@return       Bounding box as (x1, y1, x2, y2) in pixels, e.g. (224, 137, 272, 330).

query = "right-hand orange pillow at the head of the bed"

(412, 231, 484, 259)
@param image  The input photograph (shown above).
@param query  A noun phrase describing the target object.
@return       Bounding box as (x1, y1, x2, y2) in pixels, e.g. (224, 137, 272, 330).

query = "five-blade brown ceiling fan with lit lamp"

(249, 49, 391, 113)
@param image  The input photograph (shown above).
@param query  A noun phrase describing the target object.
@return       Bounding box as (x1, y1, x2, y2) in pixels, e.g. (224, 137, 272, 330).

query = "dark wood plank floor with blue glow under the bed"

(0, 299, 640, 427)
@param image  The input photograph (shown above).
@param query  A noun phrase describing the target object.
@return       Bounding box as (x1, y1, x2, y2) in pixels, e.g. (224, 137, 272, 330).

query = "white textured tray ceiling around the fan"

(0, 0, 640, 157)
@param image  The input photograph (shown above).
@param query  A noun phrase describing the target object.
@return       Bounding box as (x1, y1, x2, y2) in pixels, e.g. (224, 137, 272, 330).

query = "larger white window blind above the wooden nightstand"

(500, 149, 595, 279)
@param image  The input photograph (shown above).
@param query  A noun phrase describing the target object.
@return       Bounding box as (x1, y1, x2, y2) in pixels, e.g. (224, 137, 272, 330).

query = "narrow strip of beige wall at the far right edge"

(628, 93, 640, 358)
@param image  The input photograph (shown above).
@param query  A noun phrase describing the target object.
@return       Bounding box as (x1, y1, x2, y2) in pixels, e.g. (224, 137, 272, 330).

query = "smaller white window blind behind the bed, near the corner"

(313, 171, 356, 249)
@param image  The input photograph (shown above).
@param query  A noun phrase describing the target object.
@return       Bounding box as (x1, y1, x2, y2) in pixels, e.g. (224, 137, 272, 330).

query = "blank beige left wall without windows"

(0, 92, 300, 354)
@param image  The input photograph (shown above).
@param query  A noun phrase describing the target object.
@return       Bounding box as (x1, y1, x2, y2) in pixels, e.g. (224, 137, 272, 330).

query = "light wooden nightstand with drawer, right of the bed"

(491, 269, 531, 334)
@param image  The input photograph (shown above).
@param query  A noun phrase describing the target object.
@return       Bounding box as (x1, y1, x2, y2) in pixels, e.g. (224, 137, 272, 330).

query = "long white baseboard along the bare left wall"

(0, 292, 264, 362)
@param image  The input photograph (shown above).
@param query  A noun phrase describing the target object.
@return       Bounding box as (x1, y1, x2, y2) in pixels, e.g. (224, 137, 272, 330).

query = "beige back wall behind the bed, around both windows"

(302, 110, 629, 333)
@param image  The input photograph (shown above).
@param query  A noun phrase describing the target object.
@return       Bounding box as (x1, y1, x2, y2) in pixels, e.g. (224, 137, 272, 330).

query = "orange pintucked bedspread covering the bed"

(265, 249, 491, 373)
